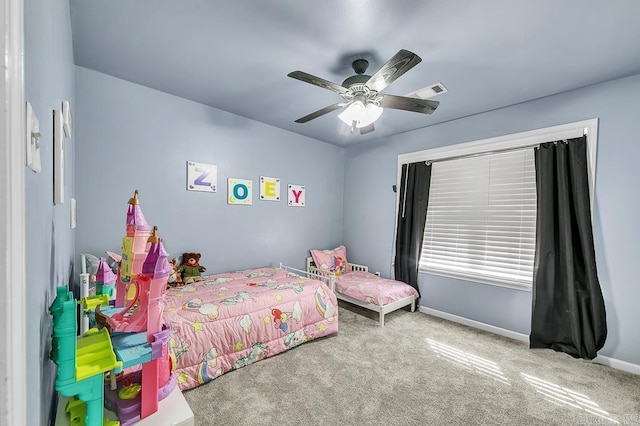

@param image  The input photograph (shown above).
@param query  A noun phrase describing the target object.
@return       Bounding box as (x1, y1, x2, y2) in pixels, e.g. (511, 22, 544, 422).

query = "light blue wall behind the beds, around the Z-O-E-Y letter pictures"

(74, 67, 344, 272)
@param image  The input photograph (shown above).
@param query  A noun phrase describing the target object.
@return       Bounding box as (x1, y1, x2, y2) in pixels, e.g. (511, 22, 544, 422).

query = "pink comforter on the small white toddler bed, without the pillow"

(335, 271, 418, 306)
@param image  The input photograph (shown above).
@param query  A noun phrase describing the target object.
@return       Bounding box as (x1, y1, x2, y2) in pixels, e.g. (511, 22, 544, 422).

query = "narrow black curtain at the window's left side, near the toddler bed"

(394, 161, 431, 295)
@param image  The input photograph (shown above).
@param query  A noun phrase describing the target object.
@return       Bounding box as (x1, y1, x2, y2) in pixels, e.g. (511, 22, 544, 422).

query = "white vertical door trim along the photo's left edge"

(0, 0, 27, 425)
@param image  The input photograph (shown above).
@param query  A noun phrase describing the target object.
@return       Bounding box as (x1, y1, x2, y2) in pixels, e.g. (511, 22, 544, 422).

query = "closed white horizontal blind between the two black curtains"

(420, 148, 537, 288)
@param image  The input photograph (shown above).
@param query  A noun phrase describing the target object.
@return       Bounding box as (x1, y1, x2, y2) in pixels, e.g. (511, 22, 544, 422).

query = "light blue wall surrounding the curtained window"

(344, 71, 640, 364)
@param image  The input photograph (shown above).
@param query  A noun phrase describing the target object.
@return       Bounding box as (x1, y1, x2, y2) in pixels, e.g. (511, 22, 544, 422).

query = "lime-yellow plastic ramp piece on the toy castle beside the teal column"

(76, 328, 122, 381)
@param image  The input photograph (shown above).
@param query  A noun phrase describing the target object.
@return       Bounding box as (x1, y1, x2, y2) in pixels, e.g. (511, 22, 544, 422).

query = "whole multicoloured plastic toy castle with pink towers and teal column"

(50, 190, 177, 426)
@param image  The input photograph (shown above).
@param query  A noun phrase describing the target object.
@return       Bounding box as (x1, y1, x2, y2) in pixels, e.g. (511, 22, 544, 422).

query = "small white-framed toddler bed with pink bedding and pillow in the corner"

(307, 246, 418, 327)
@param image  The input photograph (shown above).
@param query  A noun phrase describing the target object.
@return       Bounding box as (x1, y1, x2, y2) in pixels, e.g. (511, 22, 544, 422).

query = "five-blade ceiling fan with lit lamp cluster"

(287, 49, 440, 134)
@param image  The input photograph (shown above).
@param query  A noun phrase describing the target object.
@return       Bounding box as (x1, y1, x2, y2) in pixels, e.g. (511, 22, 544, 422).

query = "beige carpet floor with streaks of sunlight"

(185, 302, 640, 425)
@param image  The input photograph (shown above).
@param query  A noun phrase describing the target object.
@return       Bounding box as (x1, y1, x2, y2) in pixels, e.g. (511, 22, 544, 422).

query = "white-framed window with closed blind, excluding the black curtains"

(396, 119, 598, 290)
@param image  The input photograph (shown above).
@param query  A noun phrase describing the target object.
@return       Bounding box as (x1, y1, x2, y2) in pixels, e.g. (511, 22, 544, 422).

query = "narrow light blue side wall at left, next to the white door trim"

(24, 0, 75, 425)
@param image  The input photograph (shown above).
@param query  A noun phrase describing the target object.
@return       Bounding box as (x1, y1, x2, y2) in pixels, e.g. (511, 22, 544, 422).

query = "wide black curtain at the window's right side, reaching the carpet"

(529, 136, 607, 359)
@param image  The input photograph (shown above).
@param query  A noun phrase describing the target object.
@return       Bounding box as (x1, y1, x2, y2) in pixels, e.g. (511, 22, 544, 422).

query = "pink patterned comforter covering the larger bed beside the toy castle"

(164, 268, 338, 390)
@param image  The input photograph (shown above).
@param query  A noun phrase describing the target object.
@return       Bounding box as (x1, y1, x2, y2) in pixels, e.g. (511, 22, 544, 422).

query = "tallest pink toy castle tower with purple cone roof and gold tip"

(116, 189, 151, 307)
